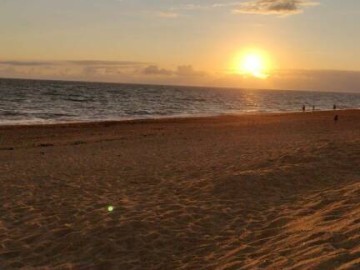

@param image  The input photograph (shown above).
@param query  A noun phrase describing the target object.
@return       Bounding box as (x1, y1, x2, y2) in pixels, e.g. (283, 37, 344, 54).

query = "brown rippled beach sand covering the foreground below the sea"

(0, 110, 360, 270)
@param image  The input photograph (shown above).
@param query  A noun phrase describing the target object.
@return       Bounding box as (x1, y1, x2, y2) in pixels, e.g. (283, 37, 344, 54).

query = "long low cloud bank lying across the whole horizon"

(0, 60, 360, 93)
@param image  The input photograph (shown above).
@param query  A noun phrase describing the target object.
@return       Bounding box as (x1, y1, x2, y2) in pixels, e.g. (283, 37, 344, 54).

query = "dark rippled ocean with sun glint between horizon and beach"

(0, 79, 360, 125)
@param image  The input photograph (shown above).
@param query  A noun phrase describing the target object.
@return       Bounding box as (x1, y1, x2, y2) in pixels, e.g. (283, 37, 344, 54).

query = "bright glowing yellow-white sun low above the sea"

(237, 51, 269, 79)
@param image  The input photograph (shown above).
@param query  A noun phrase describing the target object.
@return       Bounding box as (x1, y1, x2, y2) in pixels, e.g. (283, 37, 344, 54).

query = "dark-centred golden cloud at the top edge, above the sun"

(233, 0, 318, 16)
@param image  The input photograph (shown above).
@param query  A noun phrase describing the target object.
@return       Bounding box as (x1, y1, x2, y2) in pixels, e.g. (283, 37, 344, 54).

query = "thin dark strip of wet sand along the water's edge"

(0, 108, 354, 129)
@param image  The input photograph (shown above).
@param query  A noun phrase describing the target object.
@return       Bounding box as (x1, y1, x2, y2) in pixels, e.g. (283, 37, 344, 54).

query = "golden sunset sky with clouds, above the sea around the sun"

(0, 0, 360, 92)
